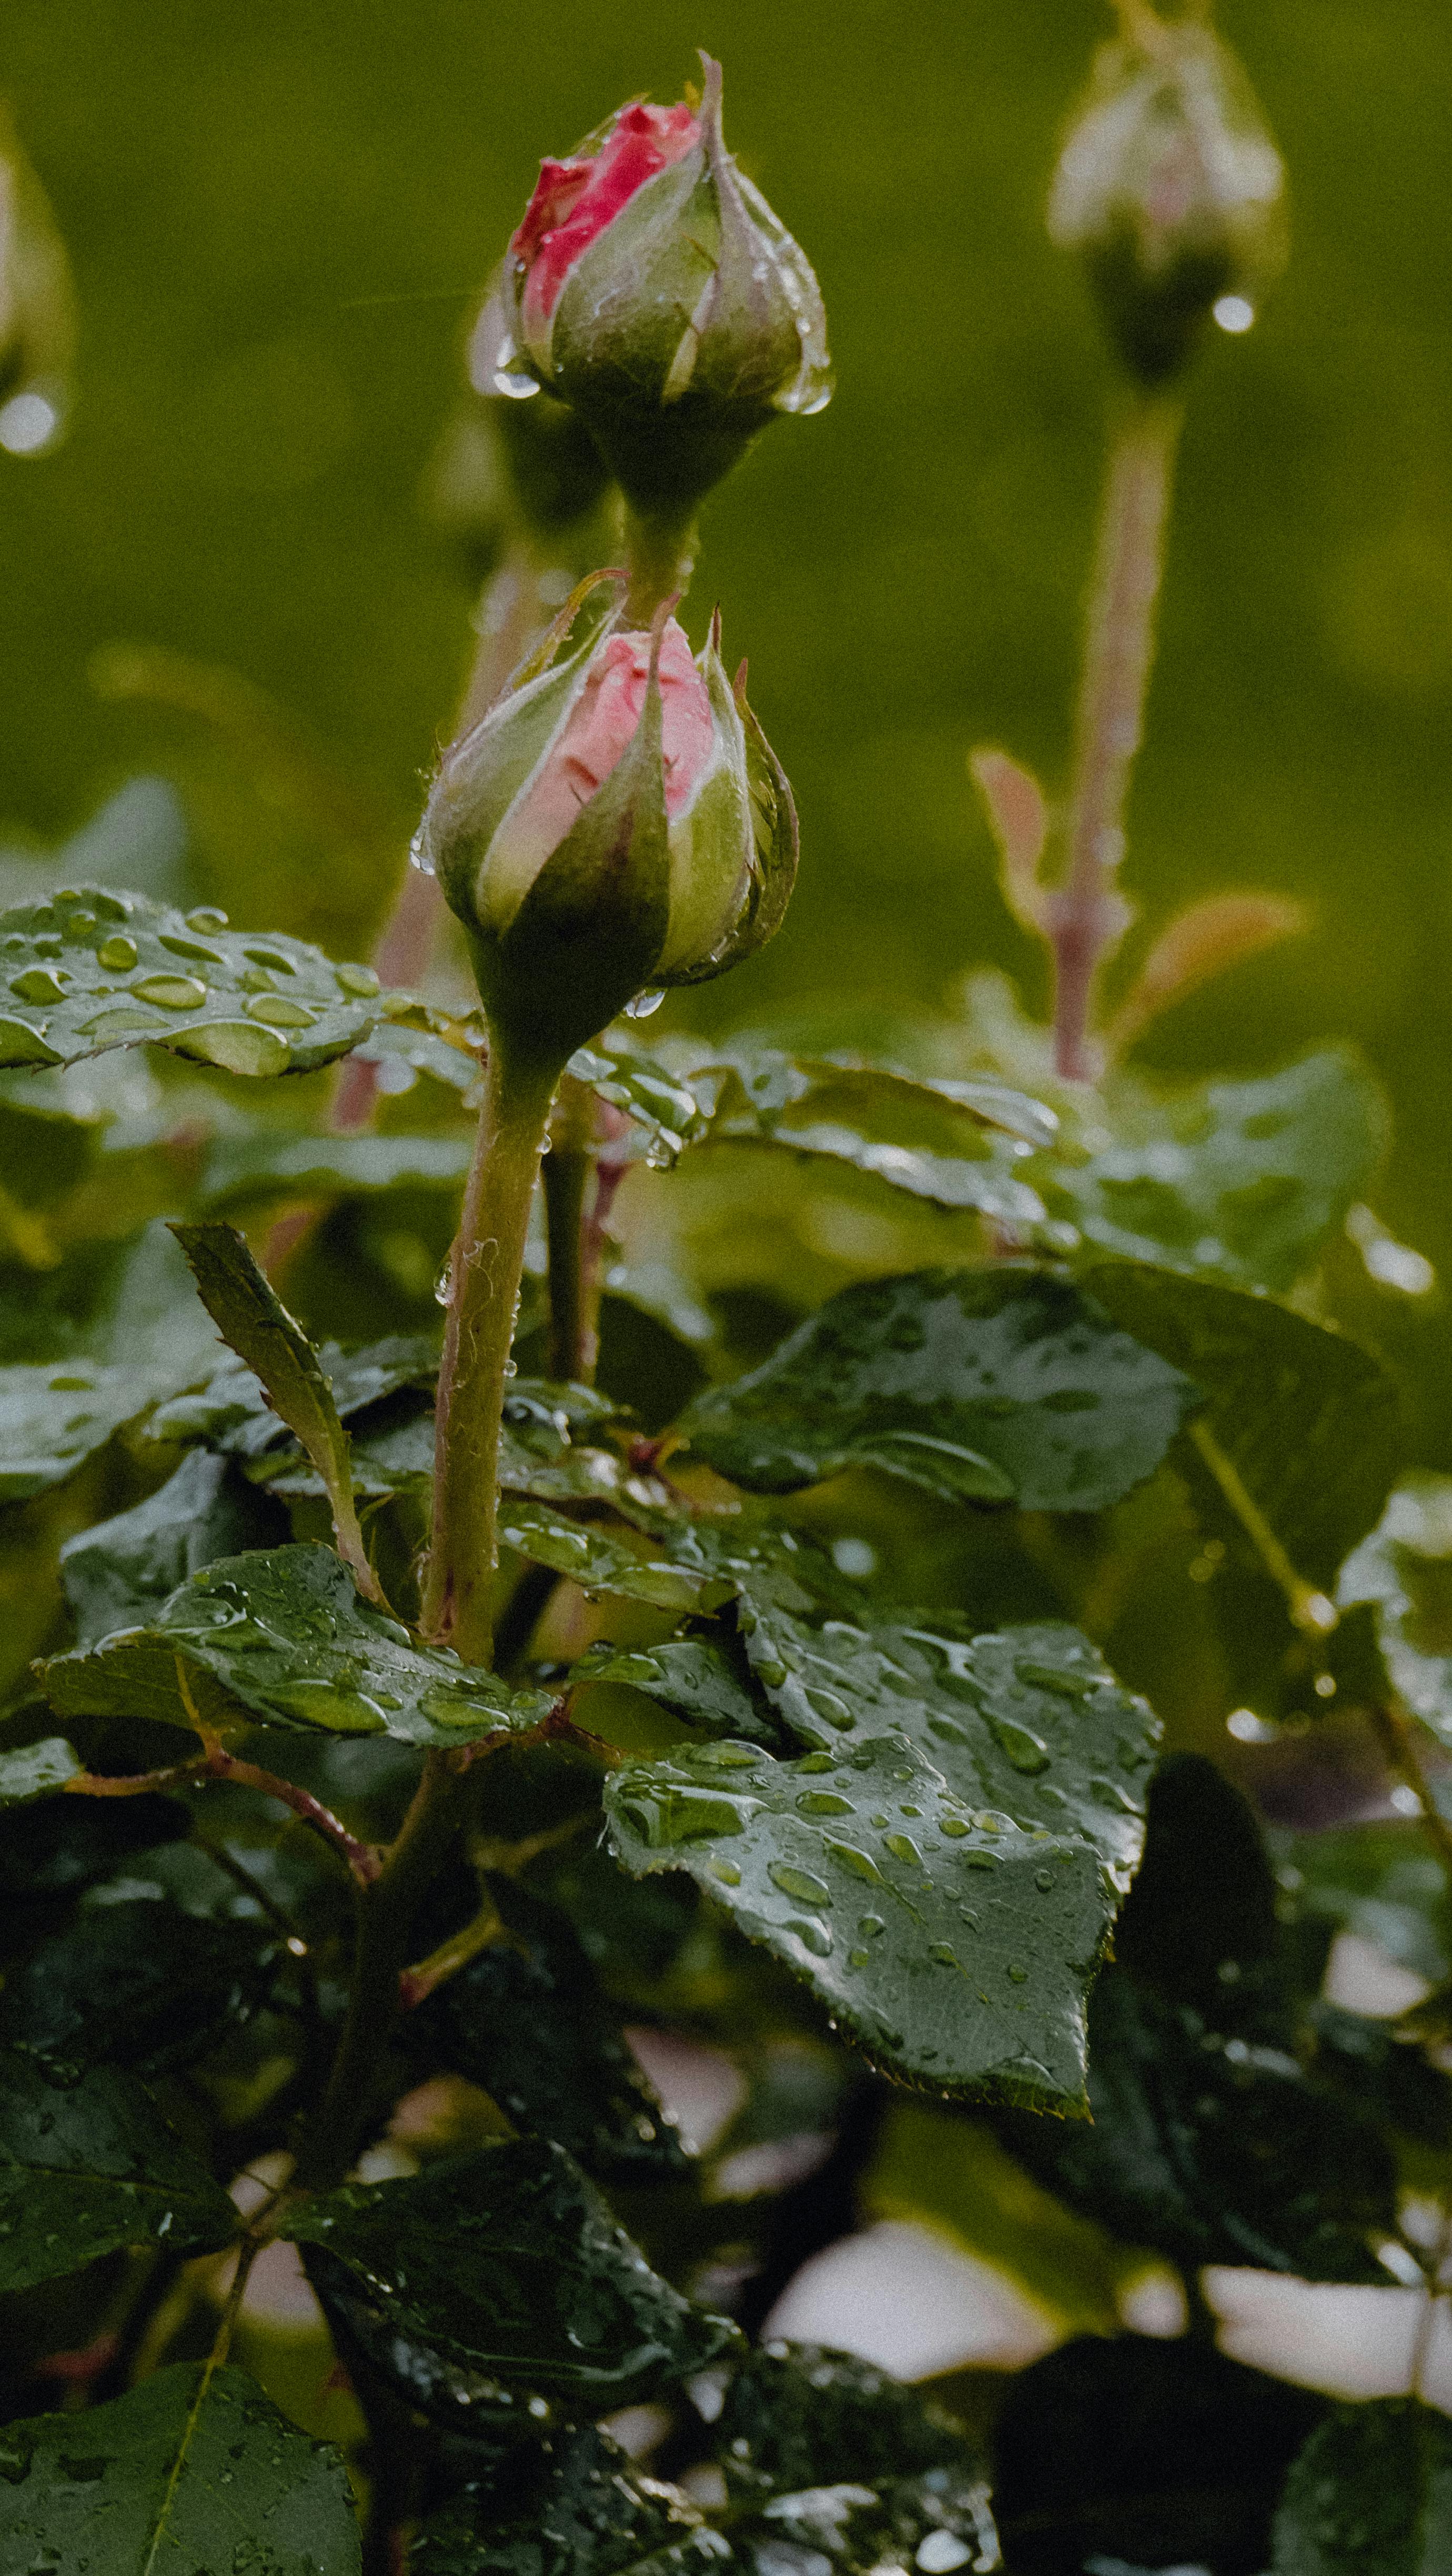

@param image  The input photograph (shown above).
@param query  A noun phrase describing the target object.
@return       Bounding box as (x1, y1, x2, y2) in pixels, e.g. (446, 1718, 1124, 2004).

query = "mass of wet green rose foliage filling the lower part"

(0, 889, 1452, 2576)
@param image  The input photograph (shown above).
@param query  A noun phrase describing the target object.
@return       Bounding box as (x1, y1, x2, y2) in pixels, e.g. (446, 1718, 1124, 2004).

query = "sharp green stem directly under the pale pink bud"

(422, 1041, 559, 1664)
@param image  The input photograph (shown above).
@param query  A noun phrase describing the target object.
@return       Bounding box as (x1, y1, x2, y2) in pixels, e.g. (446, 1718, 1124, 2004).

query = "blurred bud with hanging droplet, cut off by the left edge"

(0, 108, 75, 456)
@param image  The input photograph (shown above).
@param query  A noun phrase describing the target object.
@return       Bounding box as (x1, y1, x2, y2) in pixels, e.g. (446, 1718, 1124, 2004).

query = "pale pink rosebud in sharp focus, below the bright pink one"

(417, 582, 795, 1064)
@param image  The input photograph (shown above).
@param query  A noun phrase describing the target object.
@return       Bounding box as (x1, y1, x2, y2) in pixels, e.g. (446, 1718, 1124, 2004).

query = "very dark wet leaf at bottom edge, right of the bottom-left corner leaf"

(409, 2427, 731, 2576)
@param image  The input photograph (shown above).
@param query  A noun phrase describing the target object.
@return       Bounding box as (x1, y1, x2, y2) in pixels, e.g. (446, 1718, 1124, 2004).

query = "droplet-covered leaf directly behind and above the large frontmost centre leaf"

(739, 1587, 1158, 1894)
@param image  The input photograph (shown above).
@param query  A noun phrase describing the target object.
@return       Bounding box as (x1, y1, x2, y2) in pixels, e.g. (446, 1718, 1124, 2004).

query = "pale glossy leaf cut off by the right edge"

(1336, 1474, 1452, 1746)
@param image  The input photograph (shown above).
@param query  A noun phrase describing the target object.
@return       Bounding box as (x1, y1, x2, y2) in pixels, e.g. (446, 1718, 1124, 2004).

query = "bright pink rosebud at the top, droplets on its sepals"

(497, 57, 832, 515)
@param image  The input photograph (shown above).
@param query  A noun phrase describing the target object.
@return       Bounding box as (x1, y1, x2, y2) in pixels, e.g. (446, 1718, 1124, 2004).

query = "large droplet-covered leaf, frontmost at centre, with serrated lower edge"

(605, 1734, 1112, 2110)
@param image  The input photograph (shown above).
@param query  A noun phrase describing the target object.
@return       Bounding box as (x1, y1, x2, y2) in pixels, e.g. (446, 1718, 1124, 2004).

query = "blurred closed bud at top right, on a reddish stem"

(1048, 0, 1285, 386)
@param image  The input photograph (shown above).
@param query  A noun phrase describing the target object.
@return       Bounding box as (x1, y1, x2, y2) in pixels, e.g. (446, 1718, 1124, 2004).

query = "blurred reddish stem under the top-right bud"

(1051, 394, 1184, 1082)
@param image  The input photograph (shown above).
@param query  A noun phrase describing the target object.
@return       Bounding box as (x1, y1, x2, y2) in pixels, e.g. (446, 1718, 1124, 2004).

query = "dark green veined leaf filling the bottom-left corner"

(0, 2362, 363, 2576)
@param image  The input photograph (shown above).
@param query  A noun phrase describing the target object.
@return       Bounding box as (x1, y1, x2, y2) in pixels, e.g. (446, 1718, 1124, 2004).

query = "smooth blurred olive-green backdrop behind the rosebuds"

(0, 0, 1452, 1445)
